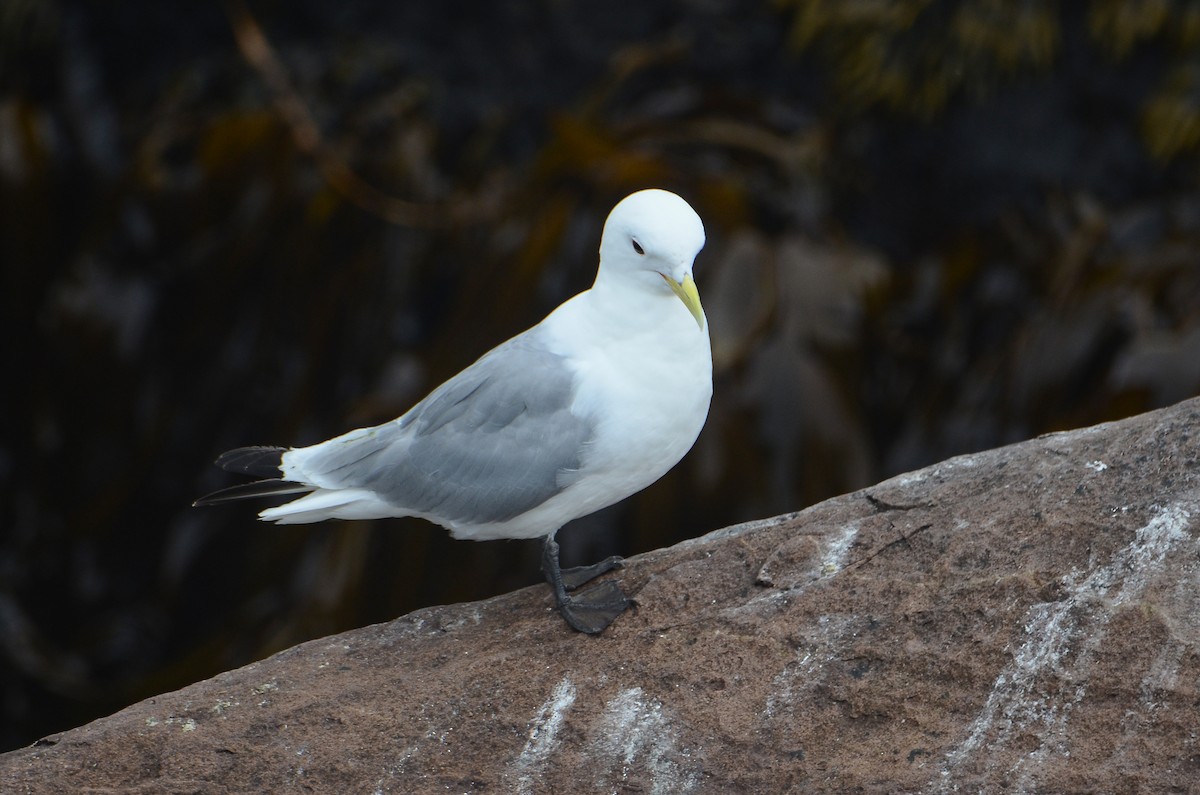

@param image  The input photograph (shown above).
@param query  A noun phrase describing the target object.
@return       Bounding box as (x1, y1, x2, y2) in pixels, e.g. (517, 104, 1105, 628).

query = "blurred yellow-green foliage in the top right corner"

(776, 0, 1200, 138)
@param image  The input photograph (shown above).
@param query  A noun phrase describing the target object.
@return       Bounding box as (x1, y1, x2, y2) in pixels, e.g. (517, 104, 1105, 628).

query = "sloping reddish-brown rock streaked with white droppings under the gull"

(0, 400, 1200, 793)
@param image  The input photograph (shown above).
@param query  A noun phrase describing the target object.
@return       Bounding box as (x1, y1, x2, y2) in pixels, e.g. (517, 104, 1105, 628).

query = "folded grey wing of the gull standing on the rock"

(306, 335, 593, 524)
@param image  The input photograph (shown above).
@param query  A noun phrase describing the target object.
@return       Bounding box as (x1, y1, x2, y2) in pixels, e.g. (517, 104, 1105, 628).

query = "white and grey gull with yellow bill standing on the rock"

(193, 189, 713, 634)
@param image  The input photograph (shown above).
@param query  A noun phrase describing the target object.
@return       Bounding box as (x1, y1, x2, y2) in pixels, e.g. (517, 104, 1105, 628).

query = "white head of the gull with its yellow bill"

(596, 189, 704, 329)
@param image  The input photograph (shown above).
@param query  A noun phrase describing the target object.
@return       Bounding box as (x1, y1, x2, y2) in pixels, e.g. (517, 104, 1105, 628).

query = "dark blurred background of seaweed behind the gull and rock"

(0, 0, 1200, 749)
